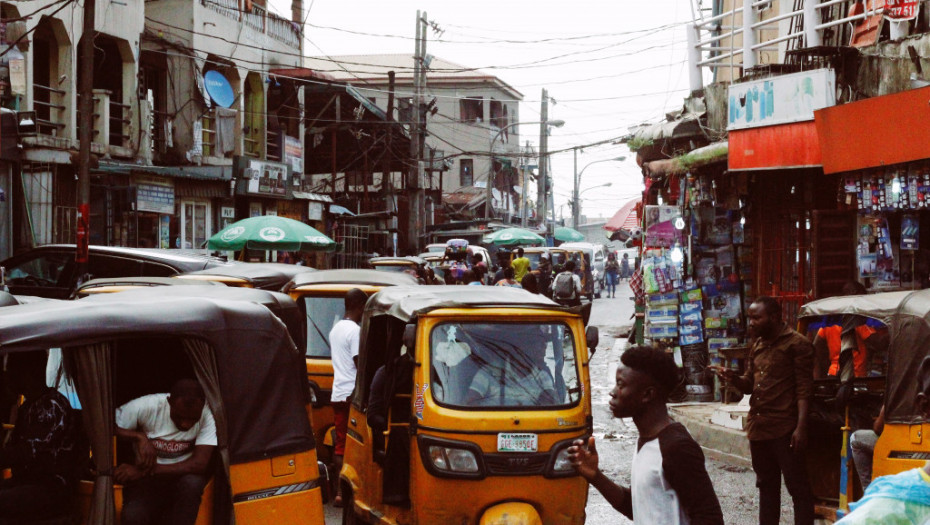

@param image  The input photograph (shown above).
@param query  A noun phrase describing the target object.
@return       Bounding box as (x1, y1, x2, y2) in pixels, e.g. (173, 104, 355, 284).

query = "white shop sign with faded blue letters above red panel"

(727, 69, 836, 130)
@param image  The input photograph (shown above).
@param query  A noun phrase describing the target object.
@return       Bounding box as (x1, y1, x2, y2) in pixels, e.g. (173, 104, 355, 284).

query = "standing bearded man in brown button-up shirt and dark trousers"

(708, 296, 814, 525)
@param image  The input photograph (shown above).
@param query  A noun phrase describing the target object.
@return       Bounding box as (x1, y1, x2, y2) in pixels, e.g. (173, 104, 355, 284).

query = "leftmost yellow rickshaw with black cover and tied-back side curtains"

(0, 287, 323, 524)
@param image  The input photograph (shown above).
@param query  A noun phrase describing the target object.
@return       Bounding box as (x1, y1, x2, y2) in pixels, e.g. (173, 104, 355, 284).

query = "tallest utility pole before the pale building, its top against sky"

(406, 11, 426, 252)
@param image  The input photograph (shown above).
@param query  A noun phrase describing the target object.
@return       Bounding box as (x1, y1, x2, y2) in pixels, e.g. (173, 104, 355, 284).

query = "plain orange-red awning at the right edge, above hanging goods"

(814, 87, 930, 173)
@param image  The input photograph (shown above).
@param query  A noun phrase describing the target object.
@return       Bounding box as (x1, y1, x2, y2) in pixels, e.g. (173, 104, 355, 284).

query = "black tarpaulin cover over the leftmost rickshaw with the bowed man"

(0, 286, 314, 463)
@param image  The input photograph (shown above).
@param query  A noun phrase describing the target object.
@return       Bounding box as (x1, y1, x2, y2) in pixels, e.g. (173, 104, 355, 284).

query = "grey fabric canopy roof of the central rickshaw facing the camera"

(365, 285, 564, 322)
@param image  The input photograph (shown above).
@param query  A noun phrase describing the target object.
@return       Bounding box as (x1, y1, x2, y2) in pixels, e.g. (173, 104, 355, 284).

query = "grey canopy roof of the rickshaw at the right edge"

(798, 290, 930, 423)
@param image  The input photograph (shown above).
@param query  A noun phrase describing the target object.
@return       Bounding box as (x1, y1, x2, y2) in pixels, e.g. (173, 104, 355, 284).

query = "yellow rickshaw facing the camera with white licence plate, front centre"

(340, 286, 597, 524)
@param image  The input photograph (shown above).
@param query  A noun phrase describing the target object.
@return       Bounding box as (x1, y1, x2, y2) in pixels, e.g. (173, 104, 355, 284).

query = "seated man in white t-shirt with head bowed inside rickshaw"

(113, 379, 216, 525)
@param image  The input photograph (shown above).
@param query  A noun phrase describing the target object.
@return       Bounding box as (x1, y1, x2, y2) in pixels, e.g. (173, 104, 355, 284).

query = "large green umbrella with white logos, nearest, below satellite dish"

(207, 215, 336, 252)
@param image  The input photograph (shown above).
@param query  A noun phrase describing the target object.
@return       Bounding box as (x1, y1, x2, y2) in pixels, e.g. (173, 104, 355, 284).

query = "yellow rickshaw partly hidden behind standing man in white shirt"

(284, 270, 417, 460)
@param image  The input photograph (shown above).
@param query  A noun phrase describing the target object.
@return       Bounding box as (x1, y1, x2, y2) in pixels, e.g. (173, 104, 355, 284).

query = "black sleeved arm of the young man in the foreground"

(659, 425, 723, 525)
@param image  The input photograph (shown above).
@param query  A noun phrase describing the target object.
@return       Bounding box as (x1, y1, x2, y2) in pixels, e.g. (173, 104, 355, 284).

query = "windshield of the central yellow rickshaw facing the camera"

(430, 323, 582, 409)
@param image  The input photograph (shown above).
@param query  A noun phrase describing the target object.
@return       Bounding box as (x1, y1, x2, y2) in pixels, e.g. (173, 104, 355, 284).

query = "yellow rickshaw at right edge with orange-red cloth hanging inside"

(798, 290, 908, 520)
